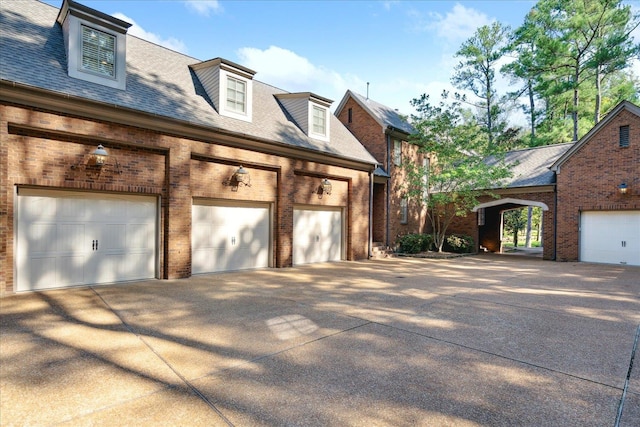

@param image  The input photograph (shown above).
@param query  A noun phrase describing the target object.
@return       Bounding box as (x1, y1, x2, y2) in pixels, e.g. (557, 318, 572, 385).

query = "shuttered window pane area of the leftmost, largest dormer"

(82, 25, 116, 77)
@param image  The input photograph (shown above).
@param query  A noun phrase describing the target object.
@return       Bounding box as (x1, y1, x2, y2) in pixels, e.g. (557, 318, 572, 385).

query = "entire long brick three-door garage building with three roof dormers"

(0, 0, 377, 295)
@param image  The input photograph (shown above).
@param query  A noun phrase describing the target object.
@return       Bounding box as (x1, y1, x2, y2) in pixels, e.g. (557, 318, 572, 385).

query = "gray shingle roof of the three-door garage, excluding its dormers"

(0, 0, 377, 164)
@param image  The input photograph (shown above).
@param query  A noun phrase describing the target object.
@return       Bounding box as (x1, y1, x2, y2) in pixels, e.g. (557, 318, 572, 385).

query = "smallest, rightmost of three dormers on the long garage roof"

(276, 92, 333, 141)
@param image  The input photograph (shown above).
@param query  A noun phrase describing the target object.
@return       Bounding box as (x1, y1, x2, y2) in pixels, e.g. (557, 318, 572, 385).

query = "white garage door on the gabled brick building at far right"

(580, 211, 640, 265)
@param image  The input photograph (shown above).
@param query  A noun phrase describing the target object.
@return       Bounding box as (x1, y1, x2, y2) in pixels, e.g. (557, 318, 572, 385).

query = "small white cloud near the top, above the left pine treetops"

(427, 3, 492, 43)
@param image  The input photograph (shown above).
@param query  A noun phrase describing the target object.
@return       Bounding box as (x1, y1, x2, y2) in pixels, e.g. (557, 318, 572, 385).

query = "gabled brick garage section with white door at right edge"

(551, 101, 640, 265)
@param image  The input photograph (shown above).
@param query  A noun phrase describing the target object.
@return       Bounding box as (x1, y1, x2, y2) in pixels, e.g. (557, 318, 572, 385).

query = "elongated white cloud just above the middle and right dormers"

(237, 46, 365, 106)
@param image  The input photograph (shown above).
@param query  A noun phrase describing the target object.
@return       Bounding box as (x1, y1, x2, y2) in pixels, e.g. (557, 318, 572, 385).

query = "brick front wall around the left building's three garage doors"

(0, 105, 370, 294)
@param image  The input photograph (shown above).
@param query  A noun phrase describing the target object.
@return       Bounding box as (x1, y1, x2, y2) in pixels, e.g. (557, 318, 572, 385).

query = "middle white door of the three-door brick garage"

(191, 201, 271, 274)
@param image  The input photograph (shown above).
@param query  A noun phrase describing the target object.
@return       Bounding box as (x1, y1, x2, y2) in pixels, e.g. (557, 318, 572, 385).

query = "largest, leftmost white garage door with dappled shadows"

(16, 189, 157, 291)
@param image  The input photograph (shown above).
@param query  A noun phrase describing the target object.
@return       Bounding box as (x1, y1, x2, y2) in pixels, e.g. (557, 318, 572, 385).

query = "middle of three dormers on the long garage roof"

(189, 58, 256, 122)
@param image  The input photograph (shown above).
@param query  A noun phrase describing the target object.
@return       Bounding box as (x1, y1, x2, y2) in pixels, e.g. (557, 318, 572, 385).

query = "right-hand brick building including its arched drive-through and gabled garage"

(449, 101, 640, 265)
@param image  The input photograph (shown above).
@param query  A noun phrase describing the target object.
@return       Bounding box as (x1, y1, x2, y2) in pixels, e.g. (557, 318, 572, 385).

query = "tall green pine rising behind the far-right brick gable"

(516, 0, 638, 140)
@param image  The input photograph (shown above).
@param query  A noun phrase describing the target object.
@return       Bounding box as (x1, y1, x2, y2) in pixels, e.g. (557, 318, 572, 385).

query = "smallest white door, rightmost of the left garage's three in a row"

(293, 209, 342, 265)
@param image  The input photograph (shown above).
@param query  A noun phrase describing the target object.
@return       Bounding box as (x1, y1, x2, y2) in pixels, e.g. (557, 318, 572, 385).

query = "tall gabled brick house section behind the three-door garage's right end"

(334, 90, 429, 251)
